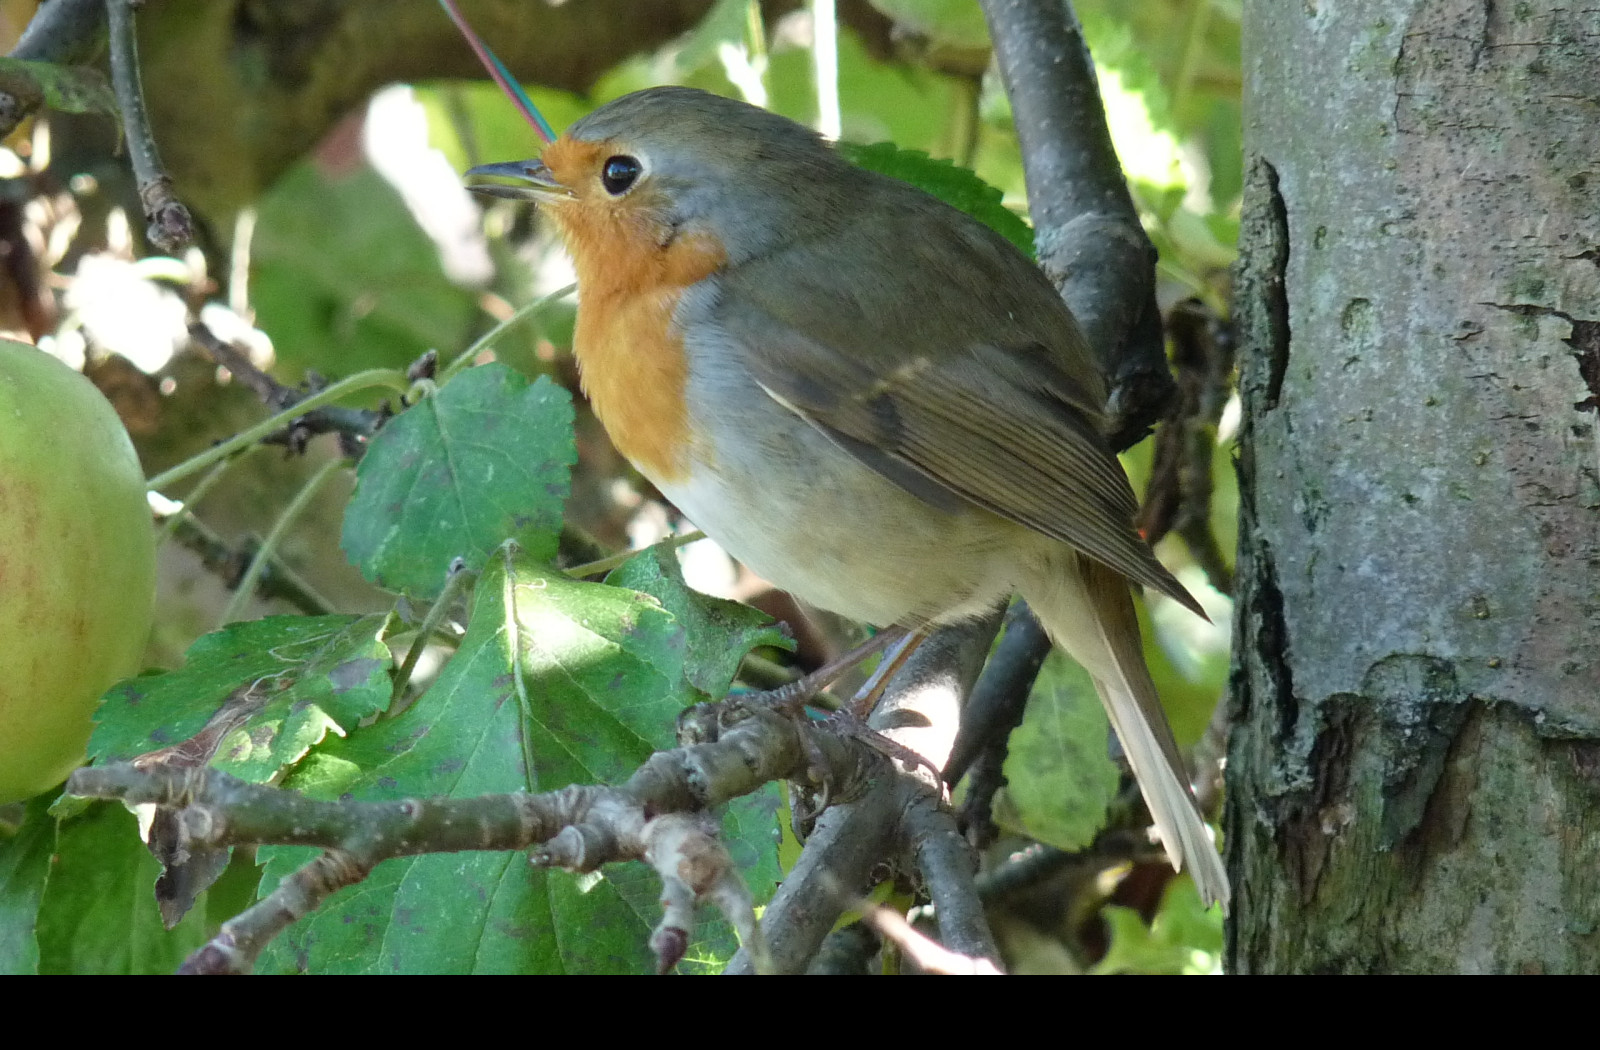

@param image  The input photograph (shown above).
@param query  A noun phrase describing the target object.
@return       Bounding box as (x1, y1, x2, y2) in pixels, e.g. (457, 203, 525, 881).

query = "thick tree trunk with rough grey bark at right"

(1226, 0, 1600, 972)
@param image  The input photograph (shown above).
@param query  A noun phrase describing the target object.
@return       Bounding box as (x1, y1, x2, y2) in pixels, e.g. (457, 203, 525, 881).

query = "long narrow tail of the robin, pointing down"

(1021, 555, 1232, 911)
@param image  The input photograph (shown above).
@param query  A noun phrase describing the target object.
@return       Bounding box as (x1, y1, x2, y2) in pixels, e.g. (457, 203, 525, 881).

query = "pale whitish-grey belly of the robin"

(656, 392, 1037, 626)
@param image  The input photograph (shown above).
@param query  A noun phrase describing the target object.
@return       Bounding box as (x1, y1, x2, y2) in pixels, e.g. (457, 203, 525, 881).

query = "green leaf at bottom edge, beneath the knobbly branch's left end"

(38, 804, 205, 973)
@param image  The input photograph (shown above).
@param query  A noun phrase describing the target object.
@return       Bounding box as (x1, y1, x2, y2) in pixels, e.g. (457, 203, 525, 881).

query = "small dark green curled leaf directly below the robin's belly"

(606, 544, 794, 699)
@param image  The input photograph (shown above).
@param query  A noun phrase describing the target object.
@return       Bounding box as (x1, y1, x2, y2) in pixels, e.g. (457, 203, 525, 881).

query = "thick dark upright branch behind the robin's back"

(982, 0, 1173, 448)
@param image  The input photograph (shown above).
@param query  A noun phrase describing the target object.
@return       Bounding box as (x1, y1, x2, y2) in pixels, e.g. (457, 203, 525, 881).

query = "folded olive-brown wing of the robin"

(714, 195, 1198, 611)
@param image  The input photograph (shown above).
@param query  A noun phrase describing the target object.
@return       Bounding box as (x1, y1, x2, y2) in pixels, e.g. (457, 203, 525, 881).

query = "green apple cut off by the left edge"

(0, 339, 155, 802)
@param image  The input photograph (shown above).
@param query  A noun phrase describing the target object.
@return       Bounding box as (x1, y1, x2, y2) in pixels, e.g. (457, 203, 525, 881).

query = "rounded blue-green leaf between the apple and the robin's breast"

(342, 363, 578, 599)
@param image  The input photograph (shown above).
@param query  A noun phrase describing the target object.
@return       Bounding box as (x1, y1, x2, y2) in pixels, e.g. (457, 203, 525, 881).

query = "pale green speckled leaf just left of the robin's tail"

(995, 653, 1122, 850)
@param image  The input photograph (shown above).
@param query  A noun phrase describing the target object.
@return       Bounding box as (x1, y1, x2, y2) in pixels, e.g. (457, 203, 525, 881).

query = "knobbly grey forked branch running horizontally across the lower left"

(67, 694, 883, 973)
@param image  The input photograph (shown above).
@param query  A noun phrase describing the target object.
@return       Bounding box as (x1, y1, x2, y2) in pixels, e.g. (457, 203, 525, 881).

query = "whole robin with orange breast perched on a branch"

(467, 86, 1230, 908)
